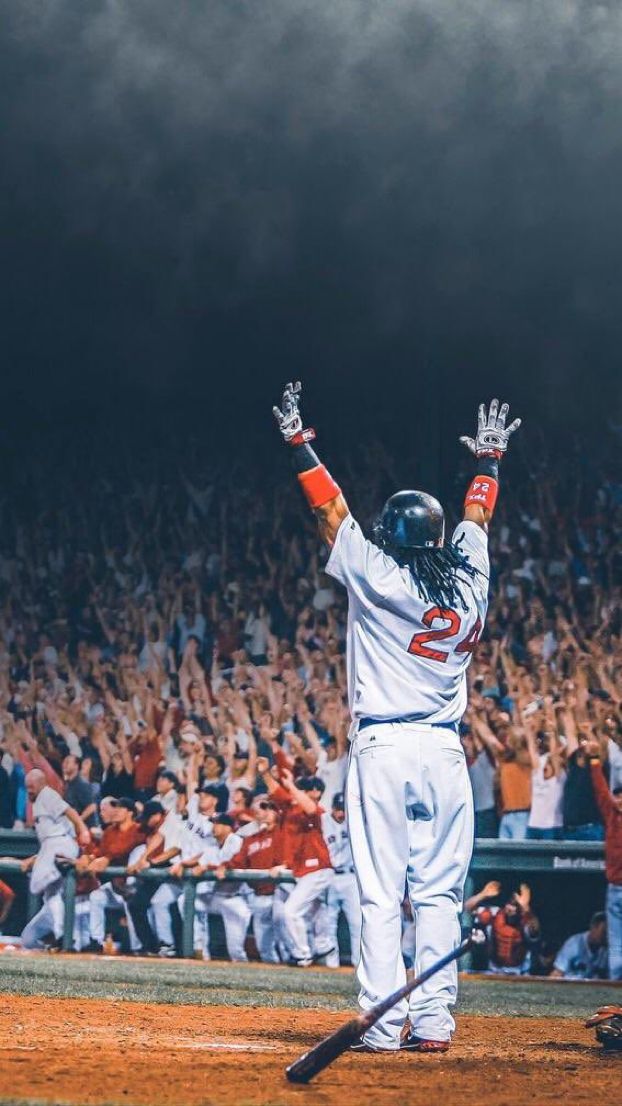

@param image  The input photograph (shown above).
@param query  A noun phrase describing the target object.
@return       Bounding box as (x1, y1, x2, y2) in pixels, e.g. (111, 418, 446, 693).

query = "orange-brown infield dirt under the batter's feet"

(0, 995, 622, 1106)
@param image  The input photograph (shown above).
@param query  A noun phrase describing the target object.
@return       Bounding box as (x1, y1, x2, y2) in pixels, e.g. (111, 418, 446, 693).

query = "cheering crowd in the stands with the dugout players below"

(0, 426, 622, 964)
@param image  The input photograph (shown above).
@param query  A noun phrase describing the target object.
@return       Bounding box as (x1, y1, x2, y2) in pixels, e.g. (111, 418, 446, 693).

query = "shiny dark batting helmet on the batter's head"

(373, 491, 445, 554)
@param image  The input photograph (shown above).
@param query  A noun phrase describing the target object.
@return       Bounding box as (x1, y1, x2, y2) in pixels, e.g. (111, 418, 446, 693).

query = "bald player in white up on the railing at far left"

(22, 768, 91, 949)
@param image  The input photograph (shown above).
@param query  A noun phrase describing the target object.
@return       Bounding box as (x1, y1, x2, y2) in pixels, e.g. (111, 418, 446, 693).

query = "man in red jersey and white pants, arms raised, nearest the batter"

(257, 757, 333, 968)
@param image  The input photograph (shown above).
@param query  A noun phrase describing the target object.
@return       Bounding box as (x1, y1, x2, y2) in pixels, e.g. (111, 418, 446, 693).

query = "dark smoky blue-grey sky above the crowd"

(0, 0, 622, 444)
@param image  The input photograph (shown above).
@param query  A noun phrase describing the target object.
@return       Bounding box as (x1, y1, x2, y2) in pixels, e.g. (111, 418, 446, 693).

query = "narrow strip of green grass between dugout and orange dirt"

(0, 953, 621, 1018)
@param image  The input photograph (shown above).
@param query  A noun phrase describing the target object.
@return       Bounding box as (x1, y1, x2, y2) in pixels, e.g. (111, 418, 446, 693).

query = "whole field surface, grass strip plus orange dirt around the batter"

(0, 953, 622, 1106)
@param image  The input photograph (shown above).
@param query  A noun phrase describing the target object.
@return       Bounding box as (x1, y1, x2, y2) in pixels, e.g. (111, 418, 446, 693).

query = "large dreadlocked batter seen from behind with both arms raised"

(273, 384, 519, 1052)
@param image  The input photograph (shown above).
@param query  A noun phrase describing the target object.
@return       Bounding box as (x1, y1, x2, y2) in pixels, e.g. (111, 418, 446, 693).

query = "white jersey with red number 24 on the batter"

(325, 515, 489, 726)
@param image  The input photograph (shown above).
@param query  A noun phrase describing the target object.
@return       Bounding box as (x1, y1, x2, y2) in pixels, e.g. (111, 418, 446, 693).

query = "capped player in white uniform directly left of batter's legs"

(322, 792, 361, 968)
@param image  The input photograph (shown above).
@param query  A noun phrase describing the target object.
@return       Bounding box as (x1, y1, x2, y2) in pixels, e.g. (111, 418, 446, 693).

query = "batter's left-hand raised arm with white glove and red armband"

(272, 380, 350, 547)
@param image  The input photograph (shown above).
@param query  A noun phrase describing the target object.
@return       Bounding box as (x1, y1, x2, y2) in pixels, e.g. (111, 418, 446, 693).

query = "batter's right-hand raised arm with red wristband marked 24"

(460, 399, 520, 530)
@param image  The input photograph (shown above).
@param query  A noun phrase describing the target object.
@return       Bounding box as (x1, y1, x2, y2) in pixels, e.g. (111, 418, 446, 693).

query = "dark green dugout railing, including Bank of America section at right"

(0, 830, 604, 957)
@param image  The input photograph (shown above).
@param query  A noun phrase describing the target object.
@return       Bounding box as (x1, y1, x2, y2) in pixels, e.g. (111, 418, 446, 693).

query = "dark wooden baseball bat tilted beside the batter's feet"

(286, 930, 485, 1083)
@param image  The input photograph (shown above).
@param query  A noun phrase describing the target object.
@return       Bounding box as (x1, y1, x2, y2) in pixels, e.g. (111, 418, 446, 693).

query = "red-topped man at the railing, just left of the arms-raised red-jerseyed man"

(226, 795, 283, 963)
